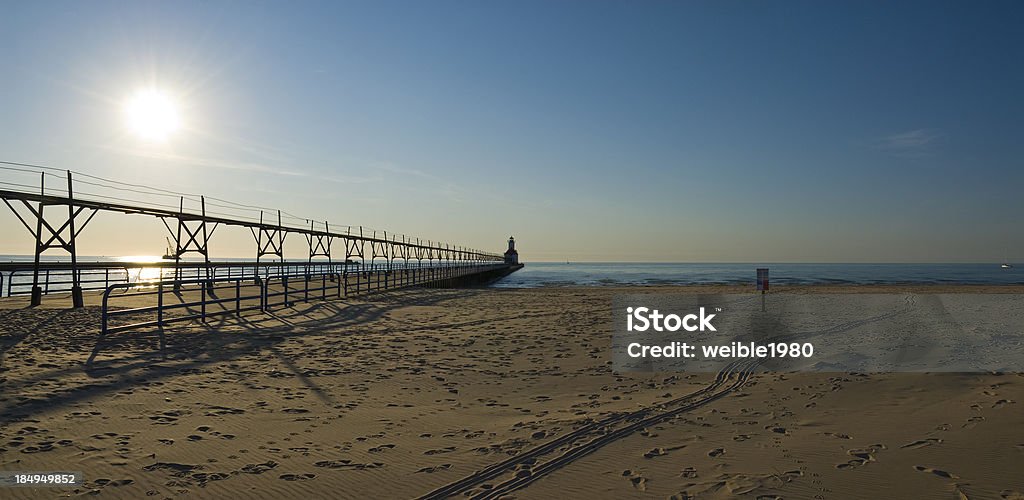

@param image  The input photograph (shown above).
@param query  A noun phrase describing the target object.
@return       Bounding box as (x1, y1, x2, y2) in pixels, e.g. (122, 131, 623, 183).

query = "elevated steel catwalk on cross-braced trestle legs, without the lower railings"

(0, 161, 504, 307)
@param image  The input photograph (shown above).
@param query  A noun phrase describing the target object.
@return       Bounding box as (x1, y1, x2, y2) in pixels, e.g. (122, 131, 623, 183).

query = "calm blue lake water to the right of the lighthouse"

(496, 262, 1024, 287)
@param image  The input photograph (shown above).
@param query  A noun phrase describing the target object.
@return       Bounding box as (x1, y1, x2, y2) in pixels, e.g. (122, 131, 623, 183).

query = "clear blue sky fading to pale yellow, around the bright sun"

(0, 0, 1024, 262)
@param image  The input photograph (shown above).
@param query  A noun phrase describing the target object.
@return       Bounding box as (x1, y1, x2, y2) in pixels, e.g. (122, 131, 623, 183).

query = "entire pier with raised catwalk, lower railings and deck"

(0, 162, 522, 323)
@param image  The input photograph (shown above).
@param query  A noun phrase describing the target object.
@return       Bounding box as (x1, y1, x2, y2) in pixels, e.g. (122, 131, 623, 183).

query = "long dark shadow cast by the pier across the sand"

(0, 289, 474, 424)
